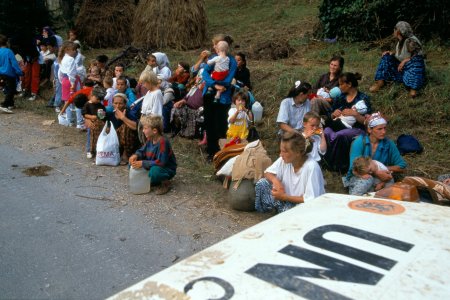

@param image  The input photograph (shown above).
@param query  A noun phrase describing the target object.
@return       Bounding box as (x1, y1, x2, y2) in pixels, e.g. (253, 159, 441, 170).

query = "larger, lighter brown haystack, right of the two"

(133, 0, 207, 50)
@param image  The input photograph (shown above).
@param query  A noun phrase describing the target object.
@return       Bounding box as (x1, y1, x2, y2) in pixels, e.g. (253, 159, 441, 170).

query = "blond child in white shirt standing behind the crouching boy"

(138, 71, 163, 143)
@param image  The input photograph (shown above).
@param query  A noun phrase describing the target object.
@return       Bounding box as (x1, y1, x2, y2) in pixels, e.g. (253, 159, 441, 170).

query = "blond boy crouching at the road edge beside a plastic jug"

(129, 116, 177, 195)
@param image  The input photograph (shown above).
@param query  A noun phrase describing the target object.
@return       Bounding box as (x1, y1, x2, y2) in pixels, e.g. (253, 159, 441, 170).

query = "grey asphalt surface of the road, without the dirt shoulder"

(0, 144, 195, 299)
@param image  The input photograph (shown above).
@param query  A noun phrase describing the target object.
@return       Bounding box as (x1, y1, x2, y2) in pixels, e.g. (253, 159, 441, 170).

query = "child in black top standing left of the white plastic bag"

(83, 86, 106, 158)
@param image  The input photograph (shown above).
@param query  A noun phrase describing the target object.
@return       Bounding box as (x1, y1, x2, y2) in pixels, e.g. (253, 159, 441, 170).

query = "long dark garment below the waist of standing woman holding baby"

(203, 93, 231, 156)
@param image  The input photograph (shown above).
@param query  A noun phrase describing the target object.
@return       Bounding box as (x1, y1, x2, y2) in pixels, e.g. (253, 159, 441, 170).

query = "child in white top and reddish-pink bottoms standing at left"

(58, 42, 84, 129)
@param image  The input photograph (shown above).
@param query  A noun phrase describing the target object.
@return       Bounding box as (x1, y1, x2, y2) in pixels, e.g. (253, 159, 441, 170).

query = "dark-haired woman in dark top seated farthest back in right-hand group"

(311, 55, 344, 116)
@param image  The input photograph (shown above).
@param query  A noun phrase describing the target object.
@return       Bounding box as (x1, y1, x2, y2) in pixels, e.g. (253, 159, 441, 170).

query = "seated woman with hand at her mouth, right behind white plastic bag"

(106, 93, 140, 161)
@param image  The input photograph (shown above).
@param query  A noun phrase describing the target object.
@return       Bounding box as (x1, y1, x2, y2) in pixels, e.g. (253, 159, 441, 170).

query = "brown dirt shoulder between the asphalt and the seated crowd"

(0, 106, 270, 250)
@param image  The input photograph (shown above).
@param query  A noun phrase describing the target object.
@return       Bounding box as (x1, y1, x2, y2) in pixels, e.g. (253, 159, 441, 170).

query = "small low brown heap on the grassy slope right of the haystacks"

(249, 38, 295, 60)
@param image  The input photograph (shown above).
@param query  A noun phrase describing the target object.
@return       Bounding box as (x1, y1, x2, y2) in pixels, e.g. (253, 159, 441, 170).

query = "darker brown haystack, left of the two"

(75, 0, 136, 48)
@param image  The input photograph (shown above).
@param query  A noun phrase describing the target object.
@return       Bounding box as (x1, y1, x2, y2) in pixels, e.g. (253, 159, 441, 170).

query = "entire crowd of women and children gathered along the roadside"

(0, 22, 448, 212)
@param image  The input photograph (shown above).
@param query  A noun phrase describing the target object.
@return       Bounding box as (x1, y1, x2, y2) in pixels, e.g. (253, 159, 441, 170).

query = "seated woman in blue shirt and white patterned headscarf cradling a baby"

(344, 113, 406, 195)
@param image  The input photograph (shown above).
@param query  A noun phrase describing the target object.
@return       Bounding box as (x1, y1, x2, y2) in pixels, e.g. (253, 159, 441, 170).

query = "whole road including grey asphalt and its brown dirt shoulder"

(0, 110, 266, 299)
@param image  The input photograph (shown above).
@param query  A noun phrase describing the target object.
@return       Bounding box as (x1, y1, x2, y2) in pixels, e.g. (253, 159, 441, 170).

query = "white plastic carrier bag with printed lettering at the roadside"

(95, 122, 120, 166)
